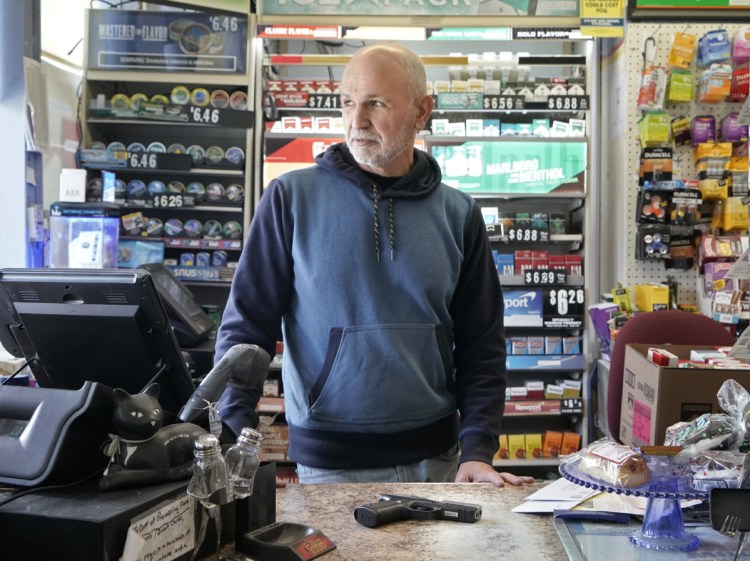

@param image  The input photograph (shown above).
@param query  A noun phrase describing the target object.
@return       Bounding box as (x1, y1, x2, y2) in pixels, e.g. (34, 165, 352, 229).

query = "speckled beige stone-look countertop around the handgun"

(260, 483, 567, 561)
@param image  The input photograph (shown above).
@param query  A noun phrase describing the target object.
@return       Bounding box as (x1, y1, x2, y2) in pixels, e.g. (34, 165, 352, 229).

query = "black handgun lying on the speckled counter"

(354, 494, 482, 528)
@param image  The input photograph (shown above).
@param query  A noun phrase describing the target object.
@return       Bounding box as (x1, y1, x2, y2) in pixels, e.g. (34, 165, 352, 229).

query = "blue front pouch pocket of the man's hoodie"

(308, 324, 455, 424)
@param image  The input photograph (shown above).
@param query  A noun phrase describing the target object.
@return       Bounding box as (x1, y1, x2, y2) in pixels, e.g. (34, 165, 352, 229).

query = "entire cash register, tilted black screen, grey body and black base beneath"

(0, 267, 276, 561)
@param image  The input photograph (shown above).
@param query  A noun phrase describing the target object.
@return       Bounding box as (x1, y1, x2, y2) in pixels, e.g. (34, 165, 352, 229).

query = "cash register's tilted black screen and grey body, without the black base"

(0, 269, 200, 486)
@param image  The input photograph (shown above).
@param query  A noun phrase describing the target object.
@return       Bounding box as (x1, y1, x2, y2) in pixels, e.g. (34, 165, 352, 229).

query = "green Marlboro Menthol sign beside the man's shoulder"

(432, 141, 586, 194)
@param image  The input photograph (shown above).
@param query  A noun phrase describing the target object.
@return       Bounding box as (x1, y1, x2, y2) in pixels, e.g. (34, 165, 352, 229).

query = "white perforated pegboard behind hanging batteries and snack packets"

(620, 22, 747, 304)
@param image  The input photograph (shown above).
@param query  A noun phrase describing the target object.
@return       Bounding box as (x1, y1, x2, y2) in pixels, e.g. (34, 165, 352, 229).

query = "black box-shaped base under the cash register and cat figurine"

(0, 463, 276, 561)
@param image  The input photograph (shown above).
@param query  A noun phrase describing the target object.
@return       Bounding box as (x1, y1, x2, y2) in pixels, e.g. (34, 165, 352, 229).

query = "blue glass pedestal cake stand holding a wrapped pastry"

(560, 456, 708, 551)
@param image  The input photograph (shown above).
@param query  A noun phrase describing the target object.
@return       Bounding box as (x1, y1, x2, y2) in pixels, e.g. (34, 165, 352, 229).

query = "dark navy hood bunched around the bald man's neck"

(315, 142, 442, 199)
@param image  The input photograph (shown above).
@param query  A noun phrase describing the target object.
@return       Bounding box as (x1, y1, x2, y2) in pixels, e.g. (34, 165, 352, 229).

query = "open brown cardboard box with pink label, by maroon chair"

(620, 344, 750, 446)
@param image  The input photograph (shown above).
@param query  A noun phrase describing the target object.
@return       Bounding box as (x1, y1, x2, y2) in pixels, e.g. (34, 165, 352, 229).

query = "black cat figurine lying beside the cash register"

(99, 384, 207, 490)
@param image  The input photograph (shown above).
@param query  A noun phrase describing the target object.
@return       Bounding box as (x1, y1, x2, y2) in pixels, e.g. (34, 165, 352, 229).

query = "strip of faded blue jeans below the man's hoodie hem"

(297, 445, 458, 483)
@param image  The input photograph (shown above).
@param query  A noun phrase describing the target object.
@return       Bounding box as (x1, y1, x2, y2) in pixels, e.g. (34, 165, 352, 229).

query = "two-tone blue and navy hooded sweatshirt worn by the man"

(216, 144, 507, 469)
